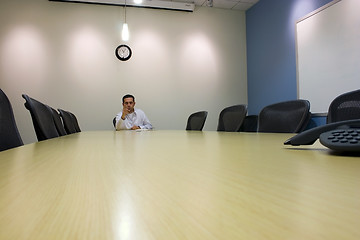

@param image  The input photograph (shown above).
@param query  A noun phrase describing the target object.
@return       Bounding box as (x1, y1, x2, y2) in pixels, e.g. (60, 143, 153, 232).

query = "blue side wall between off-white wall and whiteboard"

(246, 0, 331, 116)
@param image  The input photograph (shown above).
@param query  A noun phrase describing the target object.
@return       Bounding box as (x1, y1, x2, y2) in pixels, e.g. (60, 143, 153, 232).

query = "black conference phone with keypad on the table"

(284, 119, 360, 152)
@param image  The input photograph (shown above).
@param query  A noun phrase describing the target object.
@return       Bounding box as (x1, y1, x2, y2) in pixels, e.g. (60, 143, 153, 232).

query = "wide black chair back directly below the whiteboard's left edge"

(258, 99, 311, 133)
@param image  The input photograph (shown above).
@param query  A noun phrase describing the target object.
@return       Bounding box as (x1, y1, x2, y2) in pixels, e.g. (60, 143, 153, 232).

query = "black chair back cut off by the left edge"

(0, 89, 24, 151)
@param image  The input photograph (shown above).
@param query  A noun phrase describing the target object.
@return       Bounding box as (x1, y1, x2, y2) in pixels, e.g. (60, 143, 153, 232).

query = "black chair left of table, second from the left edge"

(22, 94, 59, 141)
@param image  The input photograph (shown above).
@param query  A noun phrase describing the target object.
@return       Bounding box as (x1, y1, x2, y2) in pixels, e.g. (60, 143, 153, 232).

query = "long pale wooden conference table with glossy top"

(0, 130, 360, 240)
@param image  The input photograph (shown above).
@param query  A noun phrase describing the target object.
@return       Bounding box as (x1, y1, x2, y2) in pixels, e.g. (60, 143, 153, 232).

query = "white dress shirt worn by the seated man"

(116, 108, 152, 130)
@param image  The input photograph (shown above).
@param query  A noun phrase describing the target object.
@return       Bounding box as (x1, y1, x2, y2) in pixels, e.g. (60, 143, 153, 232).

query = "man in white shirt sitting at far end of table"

(116, 94, 152, 130)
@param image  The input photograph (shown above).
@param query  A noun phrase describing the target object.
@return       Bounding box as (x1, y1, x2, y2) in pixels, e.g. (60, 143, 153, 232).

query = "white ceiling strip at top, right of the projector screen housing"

(175, 0, 259, 11)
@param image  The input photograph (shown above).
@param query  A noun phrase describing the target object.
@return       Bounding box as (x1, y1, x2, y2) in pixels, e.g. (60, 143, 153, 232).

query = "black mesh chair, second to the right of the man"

(217, 105, 247, 132)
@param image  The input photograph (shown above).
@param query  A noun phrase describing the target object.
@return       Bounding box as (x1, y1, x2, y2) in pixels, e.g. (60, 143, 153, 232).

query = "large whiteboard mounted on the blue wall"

(296, 0, 360, 113)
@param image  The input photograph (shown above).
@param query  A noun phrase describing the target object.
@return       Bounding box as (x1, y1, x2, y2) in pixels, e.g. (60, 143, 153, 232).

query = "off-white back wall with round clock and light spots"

(0, 0, 247, 143)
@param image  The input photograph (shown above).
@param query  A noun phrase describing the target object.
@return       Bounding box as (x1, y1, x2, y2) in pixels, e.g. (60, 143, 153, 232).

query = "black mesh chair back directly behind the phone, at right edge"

(326, 89, 360, 123)
